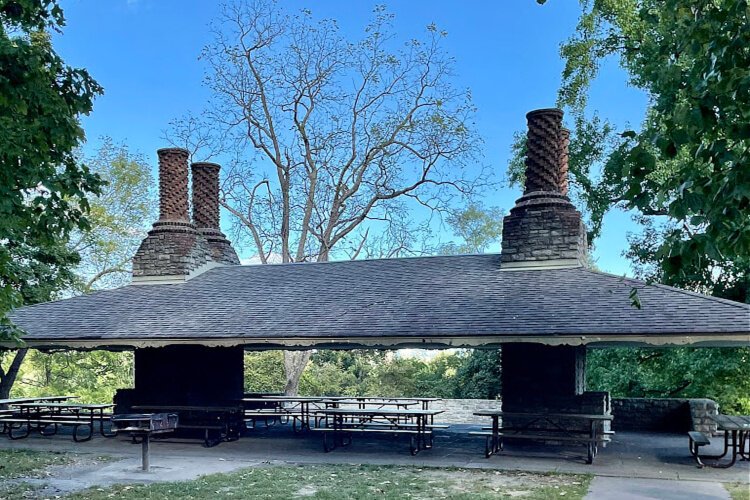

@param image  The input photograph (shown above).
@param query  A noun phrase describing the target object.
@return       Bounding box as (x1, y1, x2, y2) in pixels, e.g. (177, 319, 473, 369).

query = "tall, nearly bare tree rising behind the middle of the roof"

(166, 0, 487, 393)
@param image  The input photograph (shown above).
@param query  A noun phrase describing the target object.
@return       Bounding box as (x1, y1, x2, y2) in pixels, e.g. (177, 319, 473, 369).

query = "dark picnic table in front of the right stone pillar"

(469, 410, 613, 464)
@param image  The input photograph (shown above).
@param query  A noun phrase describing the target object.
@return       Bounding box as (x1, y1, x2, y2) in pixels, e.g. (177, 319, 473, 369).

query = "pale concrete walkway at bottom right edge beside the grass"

(586, 476, 730, 500)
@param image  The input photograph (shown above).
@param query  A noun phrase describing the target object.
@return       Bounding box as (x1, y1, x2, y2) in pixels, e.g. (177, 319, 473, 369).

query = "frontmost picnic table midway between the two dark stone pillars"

(312, 408, 447, 455)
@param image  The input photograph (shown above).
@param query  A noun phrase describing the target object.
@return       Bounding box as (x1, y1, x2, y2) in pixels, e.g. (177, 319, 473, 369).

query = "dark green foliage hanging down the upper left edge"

(0, 0, 102, 335)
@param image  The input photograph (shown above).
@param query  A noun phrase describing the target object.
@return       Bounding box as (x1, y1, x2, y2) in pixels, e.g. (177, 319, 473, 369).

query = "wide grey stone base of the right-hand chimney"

(501, 191, 588, 269)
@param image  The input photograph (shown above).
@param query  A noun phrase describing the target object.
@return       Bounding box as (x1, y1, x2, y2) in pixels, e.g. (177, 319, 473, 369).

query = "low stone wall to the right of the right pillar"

(612, 398, 719, 434)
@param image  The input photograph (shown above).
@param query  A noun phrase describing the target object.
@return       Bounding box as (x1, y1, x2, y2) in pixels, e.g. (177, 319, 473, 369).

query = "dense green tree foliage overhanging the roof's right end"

(560, 0, 750, 301)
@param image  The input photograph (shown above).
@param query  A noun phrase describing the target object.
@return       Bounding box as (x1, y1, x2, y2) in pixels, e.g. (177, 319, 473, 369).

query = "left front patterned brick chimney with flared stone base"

(133, 148, 213, 283)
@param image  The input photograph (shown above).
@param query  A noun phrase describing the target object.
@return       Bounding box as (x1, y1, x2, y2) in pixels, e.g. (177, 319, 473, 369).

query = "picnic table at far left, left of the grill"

(2, 402, 115, 442)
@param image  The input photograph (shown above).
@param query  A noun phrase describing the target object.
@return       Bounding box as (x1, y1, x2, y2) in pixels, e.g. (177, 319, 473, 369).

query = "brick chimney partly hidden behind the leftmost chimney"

(190, 163, 240, 264)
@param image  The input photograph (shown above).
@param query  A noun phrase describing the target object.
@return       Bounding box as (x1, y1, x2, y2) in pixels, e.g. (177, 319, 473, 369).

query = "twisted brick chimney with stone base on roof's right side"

(501, 109, 587, 269)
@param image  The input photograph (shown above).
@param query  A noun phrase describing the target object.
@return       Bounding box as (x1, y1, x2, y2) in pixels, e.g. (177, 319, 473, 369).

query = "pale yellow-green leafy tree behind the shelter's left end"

(0, 137, 155, 401)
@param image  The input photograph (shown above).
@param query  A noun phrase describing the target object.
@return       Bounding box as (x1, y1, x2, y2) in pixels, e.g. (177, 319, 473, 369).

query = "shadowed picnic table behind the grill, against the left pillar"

(133, 405, 242, 448)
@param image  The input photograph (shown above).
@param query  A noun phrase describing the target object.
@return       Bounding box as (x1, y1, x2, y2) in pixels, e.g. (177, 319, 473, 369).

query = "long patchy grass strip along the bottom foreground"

(68, 465, 591, 500)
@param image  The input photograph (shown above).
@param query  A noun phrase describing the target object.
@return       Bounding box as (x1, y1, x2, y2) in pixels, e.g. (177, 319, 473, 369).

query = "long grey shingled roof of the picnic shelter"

(11, 255, 750, 348)
